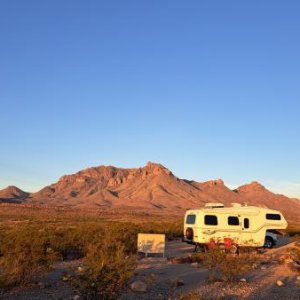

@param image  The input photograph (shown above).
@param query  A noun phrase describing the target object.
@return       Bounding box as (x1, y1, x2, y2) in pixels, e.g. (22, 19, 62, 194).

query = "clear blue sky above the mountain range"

(0, 0, 300, 198)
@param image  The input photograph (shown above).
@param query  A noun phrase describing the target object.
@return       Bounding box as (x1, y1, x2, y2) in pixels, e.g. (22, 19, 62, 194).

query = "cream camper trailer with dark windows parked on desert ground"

(184, 203, 287, 249)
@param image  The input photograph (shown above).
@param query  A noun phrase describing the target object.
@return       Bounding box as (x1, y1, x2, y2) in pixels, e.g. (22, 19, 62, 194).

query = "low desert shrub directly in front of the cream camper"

(203, 245, 257, 282)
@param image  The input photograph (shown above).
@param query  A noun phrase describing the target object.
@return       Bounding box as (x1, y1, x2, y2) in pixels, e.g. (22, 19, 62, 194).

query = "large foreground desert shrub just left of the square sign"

(74, 231, 135, 299)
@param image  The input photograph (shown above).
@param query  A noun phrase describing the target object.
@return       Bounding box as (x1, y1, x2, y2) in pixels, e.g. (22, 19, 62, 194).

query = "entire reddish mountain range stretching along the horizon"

(0, 162, 300, 220)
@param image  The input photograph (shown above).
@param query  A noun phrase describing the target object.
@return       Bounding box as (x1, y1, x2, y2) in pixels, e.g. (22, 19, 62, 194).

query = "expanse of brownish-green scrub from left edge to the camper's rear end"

(0, 217, 182, 297)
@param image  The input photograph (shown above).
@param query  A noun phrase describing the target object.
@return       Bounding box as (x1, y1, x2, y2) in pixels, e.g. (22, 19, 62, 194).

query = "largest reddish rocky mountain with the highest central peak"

(32, 163, 205, 209)
